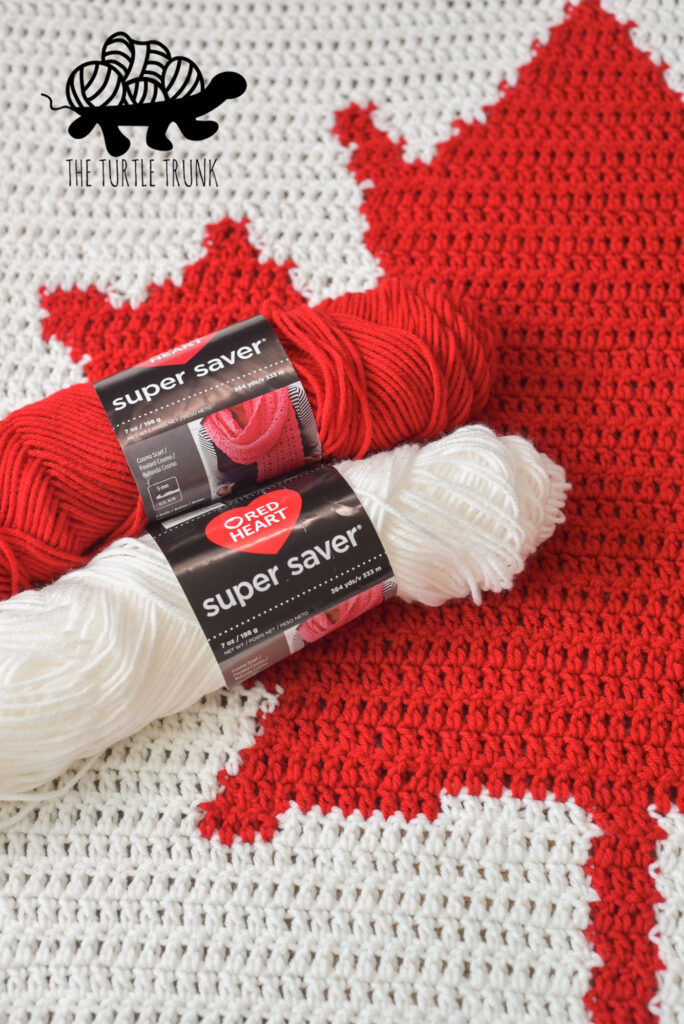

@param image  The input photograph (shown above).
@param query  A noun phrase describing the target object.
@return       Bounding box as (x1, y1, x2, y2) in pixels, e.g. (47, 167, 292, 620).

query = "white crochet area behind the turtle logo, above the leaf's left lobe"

(0, 0, 577, 415)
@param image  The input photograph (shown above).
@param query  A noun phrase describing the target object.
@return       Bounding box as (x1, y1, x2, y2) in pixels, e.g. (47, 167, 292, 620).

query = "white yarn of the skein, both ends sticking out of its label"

(0, 426, 568, 800)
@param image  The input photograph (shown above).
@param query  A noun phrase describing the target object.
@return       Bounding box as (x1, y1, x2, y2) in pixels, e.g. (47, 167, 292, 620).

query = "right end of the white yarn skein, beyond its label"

(338, 426, 569, 605)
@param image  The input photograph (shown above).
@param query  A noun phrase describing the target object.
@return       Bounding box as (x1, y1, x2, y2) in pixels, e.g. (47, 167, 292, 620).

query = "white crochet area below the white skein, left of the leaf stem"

(0, 687, 599, 1024)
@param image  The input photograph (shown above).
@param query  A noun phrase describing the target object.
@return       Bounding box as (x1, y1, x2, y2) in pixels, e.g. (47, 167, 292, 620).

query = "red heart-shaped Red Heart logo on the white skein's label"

(205, 487, 302, 555)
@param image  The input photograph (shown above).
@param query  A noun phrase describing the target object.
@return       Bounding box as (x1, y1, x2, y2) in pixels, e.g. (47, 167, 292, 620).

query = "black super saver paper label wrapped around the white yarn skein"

(151, 466, 395, 684)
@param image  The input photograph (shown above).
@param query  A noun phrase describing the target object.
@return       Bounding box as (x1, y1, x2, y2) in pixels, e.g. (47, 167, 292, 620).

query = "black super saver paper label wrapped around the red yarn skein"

(95, 316, 320, 523)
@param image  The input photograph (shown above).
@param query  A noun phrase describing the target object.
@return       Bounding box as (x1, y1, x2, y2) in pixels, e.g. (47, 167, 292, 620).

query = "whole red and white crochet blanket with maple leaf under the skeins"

(0, 0, 684, 1024)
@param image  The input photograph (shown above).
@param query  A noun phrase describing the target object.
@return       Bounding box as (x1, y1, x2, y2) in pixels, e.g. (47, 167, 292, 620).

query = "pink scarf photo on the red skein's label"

(204, 388, 304, 482)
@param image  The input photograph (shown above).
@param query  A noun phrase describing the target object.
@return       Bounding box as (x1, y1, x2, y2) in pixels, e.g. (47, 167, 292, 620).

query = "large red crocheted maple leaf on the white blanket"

(38, 0, 684, 1022)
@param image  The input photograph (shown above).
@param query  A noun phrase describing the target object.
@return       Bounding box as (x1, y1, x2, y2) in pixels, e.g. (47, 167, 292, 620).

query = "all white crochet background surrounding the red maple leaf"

(0, 0, 684, 1024)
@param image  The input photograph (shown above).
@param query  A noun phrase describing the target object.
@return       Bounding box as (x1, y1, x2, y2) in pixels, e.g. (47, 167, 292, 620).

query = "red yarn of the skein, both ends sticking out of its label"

(0, 279, 497, 598)
